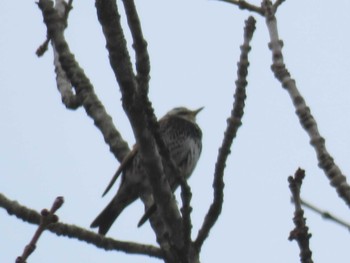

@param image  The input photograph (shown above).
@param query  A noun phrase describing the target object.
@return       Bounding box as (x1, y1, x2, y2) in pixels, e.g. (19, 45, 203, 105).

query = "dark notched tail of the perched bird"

(90, 189, 137, 235)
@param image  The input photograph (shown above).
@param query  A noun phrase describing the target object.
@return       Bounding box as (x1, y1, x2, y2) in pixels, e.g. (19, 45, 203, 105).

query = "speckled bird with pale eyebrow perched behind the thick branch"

(90, 107, 203, 235)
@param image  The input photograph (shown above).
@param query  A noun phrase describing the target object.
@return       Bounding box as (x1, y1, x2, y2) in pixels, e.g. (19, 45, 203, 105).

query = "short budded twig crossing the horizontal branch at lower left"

(16, 196, 64, 263)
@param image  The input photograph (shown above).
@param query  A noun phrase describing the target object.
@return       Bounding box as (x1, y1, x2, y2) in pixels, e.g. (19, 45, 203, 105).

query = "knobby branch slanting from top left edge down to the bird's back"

(39, 0, 129, 162)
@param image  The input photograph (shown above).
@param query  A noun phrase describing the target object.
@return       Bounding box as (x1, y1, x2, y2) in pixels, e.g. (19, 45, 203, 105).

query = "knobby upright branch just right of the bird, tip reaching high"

(195, 16, 256, 251)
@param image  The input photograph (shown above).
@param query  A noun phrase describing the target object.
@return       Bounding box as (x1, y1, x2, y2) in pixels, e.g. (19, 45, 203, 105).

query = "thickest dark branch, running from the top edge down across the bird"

(96, 0, 182, 260)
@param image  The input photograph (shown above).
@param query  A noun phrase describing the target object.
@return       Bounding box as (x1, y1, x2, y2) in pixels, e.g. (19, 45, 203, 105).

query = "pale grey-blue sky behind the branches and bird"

(0, 0, 350, 263)
